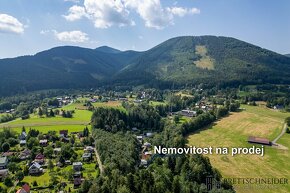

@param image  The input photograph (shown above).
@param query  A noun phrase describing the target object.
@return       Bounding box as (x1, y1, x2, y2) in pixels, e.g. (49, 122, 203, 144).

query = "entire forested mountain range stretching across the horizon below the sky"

(0, 36, 290, 96)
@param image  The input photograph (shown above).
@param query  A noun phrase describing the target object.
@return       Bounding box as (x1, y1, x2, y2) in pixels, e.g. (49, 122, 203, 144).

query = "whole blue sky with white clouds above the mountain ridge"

(0, 0, 290, 58)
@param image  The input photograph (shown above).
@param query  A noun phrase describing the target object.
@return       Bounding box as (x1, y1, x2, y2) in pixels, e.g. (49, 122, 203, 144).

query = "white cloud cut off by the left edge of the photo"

(0, 14, 24, 34)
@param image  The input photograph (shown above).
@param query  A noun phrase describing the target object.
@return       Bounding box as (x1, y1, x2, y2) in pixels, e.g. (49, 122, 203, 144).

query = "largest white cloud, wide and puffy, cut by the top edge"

(64, 0, 200, 29)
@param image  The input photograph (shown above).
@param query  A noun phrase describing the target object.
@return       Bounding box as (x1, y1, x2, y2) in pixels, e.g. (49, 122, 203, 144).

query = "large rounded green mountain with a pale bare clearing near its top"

(114, 36, 290, 85)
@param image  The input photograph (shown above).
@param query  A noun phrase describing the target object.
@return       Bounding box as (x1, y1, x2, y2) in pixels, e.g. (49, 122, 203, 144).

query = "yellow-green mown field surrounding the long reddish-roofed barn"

(187, 106, 290, 193)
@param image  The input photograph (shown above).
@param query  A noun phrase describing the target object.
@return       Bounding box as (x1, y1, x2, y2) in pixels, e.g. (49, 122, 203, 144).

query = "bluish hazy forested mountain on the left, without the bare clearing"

(0, 46, 139, 96)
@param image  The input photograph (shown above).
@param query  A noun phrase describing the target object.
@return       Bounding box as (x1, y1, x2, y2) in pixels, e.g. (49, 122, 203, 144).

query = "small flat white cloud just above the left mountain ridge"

(54, 30, 89, 43)
